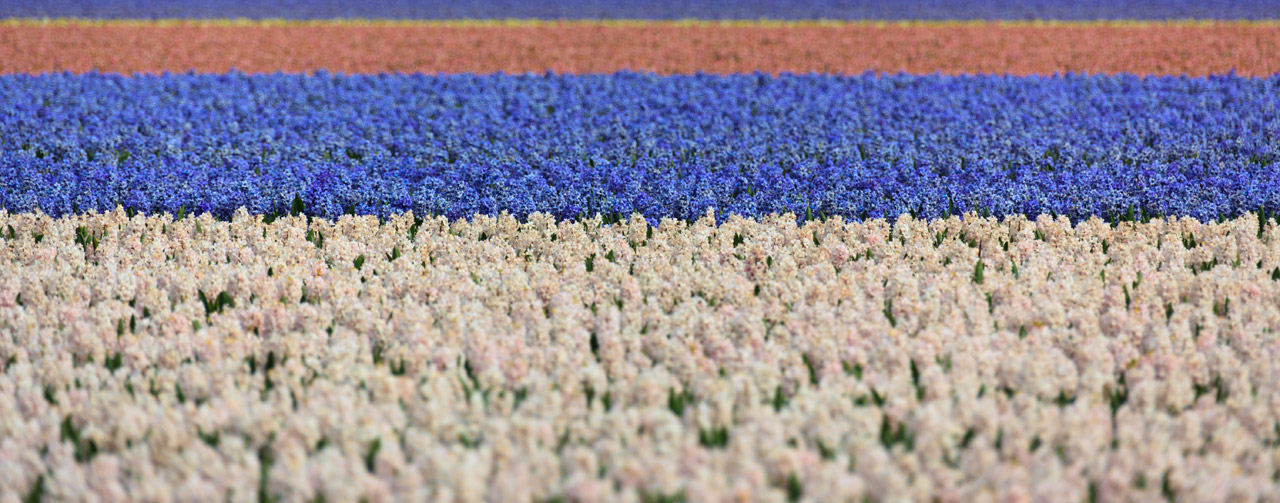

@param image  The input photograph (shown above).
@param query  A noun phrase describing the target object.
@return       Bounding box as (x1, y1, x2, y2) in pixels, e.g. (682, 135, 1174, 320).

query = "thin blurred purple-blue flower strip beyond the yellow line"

(10, 0, 1276, 20)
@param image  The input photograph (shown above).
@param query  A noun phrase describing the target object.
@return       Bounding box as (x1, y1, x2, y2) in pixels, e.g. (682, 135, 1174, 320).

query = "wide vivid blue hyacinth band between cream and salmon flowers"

(0, 73, 1280, 221)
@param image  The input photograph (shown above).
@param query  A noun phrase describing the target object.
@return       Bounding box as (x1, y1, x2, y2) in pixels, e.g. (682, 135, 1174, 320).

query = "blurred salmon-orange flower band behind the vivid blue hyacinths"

(0, 22, 1280, 76)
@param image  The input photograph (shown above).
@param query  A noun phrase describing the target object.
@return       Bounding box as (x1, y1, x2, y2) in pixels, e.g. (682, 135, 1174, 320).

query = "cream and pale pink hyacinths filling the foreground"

(0, 210, 1280, 502)
